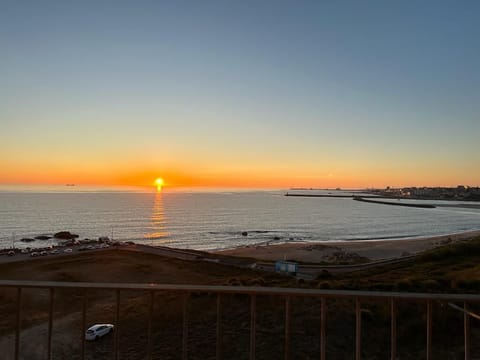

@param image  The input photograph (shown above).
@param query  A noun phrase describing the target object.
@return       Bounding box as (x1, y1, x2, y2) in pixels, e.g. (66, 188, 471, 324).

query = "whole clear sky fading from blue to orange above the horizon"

(0, 0, 480, 189)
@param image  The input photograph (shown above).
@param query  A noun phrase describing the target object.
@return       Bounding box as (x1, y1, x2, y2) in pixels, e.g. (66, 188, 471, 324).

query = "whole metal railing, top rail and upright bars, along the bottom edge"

(0, 280, 480, 360)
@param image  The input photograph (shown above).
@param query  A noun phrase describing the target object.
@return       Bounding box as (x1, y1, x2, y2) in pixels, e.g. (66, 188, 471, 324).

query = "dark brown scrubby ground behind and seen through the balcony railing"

(0, 238, 480, 359)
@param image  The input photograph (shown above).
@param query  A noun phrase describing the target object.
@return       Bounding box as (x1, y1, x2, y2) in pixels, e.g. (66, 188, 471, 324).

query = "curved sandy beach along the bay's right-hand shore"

(217, 231, 480, 263)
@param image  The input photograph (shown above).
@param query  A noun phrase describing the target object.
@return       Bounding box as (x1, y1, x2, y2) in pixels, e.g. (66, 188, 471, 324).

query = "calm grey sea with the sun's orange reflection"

(0, 191, 480, 250)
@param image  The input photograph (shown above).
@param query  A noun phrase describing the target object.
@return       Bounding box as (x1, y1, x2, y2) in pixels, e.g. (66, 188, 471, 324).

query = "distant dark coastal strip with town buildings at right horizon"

(369, 185, 480, 201)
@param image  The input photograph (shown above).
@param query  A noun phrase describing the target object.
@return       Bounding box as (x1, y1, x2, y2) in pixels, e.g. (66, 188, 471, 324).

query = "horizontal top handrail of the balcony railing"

(0, 280, 480, 302)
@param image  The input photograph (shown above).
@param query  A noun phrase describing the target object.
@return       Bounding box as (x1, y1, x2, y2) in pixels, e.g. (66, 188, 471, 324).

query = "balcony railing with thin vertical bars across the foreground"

(0, 280, 480, 360)
